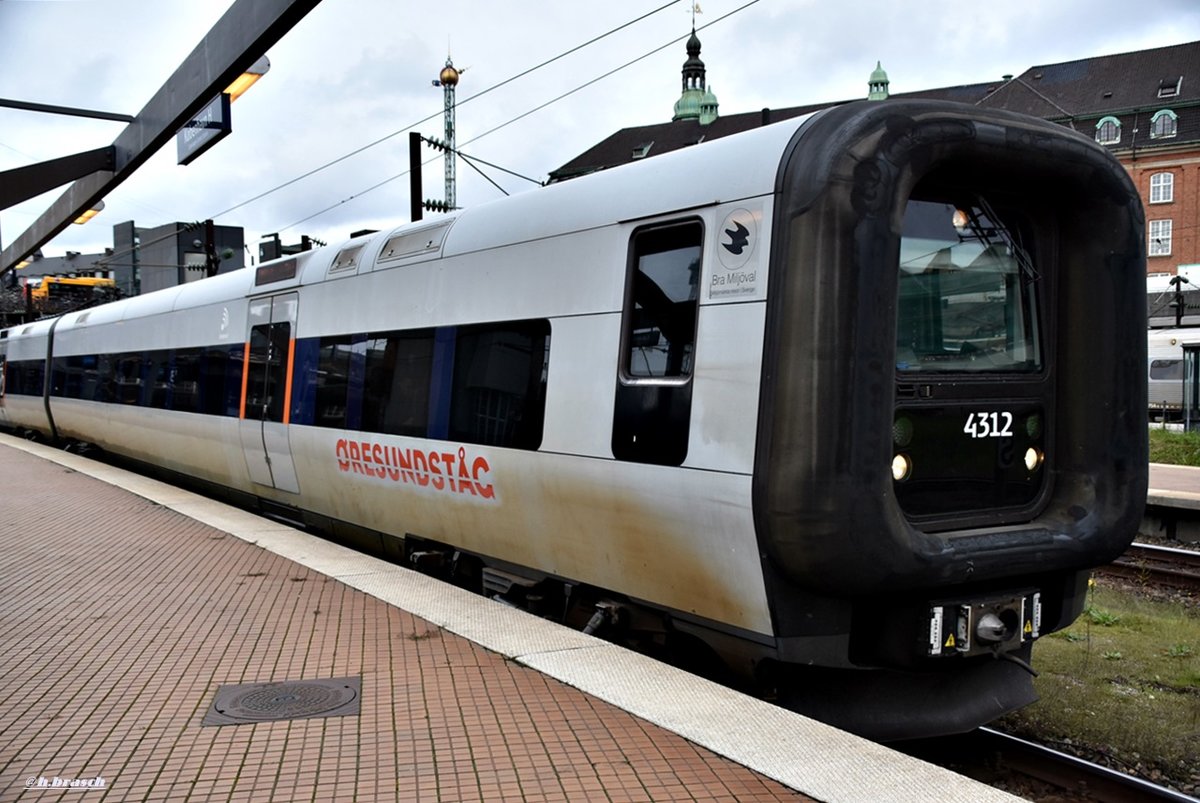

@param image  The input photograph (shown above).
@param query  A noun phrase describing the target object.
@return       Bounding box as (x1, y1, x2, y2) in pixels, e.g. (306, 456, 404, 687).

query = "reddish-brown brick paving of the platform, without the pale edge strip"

(0, 444, 811, 803)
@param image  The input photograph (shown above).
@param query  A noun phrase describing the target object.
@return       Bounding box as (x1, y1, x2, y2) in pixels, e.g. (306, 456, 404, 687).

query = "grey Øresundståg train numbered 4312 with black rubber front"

(0, 101, 1146, 738)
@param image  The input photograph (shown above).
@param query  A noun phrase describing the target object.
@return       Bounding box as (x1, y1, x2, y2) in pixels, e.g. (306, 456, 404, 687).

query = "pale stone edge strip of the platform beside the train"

(0, 436, 1022, 803)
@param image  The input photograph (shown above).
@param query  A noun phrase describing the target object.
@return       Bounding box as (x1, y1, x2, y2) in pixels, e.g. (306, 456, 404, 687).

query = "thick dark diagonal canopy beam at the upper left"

(0, 0, 320, 276)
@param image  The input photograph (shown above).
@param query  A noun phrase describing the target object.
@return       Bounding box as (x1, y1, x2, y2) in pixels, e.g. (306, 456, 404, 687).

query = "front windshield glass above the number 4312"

(896, 199, 1042, 373)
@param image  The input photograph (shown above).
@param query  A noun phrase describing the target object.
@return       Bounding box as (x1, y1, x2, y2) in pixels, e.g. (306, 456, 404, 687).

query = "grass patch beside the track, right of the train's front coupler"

(996, 583, 1200, 785)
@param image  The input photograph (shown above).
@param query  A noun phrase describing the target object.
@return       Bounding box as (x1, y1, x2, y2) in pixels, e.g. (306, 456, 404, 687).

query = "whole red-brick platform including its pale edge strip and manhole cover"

(0, 436, 1018, 803)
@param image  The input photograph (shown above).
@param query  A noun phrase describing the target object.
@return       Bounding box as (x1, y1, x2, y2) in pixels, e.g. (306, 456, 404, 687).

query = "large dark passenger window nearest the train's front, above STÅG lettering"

(448, 319, 550, 450)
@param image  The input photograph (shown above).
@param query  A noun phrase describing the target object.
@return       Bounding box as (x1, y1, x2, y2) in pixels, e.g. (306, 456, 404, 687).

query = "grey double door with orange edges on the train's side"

(239, 293, 300, 493)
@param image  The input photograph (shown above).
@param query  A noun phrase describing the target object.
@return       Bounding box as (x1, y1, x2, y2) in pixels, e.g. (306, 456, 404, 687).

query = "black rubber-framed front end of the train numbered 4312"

(754, 101, 1147, 738)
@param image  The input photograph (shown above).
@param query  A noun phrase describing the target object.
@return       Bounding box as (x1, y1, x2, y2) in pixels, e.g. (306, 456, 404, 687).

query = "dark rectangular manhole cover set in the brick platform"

(202, 677, 362, 725)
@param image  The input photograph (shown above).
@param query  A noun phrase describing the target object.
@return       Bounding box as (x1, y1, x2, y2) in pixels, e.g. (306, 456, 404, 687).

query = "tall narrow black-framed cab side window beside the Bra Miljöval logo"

(612, 220, 704, 466)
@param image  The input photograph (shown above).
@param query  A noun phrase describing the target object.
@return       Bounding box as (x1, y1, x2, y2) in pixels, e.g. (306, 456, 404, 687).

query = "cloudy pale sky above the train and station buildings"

(0, 0, 1200, 261)
